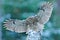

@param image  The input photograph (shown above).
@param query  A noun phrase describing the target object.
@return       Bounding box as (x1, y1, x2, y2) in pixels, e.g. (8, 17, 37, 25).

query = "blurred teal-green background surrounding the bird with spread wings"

(0, 0, 60, 40)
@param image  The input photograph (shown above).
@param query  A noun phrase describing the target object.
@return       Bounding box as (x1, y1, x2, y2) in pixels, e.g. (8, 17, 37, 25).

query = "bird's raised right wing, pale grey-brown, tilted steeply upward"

(37, 2, 53, 24)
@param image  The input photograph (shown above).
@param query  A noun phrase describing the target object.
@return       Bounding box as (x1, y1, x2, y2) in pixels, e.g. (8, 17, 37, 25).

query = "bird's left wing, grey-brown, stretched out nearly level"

(4, 19, 26, 33)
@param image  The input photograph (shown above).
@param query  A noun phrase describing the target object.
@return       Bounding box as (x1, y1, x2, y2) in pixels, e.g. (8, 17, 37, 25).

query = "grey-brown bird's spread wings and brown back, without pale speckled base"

(4, 2, 53, 33)
